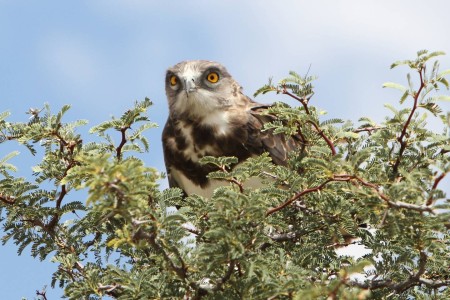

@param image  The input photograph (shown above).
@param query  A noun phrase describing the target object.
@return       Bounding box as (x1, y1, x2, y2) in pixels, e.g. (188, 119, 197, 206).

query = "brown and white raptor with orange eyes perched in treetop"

(162, 60, 298, 197)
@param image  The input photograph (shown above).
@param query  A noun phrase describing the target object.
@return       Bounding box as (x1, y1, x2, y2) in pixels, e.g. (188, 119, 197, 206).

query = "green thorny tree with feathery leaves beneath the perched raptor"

(0, 51, 450, 299)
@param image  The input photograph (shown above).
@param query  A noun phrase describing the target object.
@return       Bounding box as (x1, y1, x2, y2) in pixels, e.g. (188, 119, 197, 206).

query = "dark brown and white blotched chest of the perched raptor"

(163, 112, 259, 190)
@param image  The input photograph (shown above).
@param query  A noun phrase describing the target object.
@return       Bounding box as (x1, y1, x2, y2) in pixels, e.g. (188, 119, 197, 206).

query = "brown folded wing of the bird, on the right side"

(248, 104, 300, 165)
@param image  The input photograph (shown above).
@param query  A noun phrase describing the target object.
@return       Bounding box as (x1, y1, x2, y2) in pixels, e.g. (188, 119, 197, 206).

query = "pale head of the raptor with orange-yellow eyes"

(166, 60, 241, 118)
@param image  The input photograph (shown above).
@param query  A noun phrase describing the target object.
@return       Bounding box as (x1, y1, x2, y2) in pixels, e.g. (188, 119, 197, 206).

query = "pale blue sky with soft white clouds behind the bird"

(0, 0, 450, 299)
